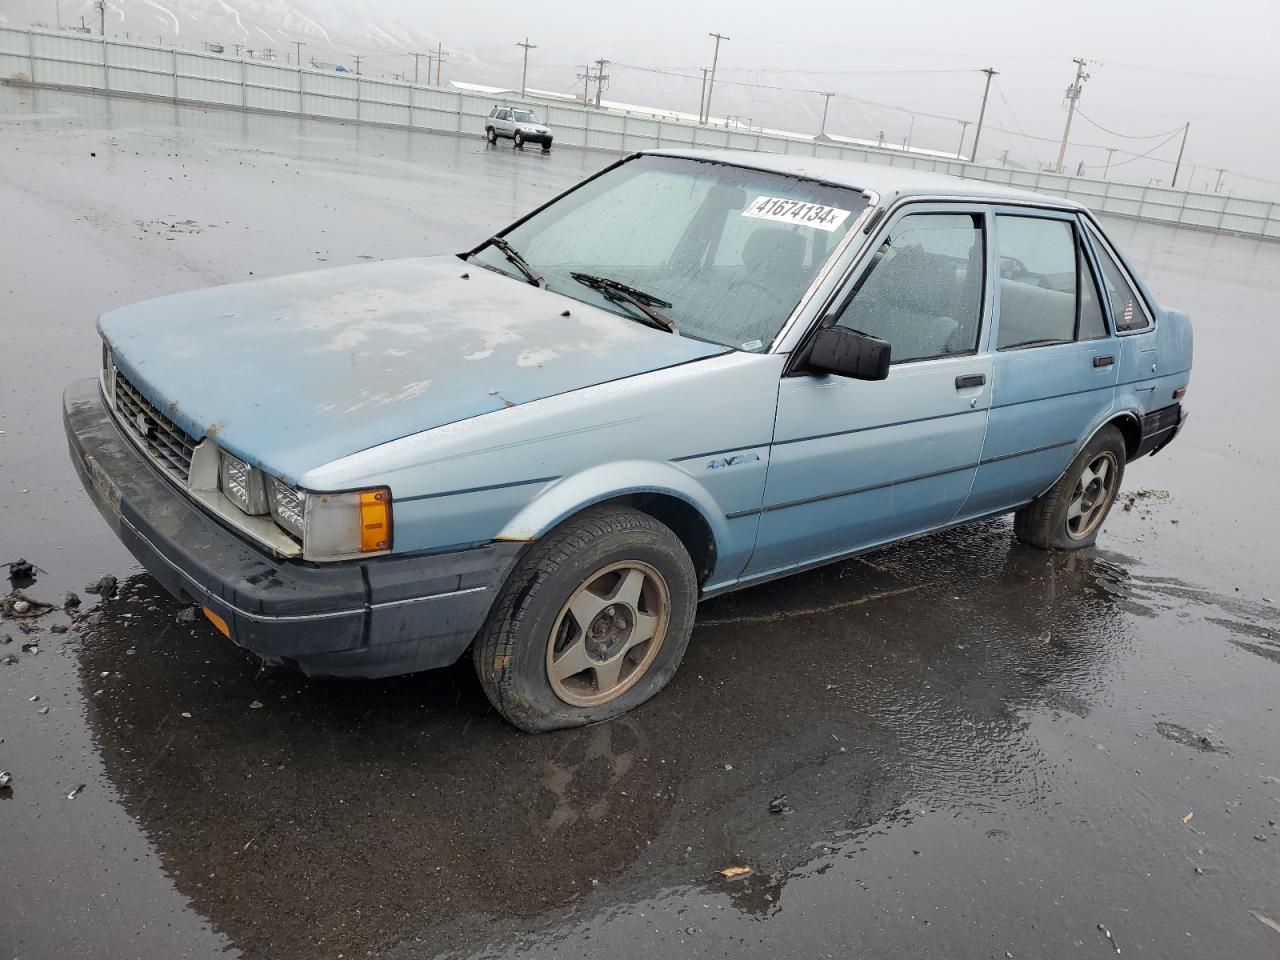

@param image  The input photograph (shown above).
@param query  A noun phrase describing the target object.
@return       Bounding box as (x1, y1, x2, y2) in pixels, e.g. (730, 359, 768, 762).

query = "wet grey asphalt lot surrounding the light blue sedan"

(0, 86, 1280, 960)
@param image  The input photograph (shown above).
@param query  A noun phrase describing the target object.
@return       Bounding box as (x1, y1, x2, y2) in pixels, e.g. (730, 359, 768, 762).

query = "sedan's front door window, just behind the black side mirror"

(836, 214, 986, 364)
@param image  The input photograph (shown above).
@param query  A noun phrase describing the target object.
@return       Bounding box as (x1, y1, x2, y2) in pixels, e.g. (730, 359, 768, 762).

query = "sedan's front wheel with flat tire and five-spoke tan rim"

(472, 507, 698, 733)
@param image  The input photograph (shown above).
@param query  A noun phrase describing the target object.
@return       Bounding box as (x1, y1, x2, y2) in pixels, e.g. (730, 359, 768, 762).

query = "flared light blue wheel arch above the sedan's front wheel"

(495, 460, 728, 547)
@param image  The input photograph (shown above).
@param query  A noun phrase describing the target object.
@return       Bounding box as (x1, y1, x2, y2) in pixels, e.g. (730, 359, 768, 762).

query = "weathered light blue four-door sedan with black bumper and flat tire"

(65, 151, 1192, 731)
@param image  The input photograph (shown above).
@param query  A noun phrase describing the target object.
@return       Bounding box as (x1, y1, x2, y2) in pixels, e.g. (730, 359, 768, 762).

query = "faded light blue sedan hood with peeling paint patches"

(99, 256, 727, 483)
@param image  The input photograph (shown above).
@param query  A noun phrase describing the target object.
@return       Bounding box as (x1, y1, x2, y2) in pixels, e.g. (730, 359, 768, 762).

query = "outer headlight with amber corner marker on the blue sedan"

(268, 477, 392, 561)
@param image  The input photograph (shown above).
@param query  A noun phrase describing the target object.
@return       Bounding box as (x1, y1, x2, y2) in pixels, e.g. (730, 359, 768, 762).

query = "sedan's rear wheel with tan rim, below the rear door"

(1014, 426, 1126, 550)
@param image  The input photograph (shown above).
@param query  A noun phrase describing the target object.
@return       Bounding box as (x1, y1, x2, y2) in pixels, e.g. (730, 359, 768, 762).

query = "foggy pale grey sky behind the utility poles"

(10, 0, 1280, 198)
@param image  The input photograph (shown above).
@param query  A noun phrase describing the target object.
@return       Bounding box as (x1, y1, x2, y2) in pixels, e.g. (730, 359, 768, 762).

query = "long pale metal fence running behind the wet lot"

(0, 27, 1280, 239)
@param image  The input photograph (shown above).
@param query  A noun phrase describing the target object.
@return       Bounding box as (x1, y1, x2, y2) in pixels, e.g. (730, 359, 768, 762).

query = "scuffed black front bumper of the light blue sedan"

(63, 380, 524, 677)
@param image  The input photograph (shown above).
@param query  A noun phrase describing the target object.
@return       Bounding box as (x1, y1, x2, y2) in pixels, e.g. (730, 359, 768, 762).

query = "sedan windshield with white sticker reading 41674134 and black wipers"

(476, 155, 867, 352)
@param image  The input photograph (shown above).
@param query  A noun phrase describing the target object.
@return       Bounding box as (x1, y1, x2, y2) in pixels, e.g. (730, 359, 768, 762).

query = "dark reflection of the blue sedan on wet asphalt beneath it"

(79, 521, 1133, 956)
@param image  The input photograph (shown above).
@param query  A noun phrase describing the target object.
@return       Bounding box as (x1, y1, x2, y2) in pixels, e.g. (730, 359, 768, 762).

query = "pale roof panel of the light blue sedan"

(641, 150, 1084, 210)
